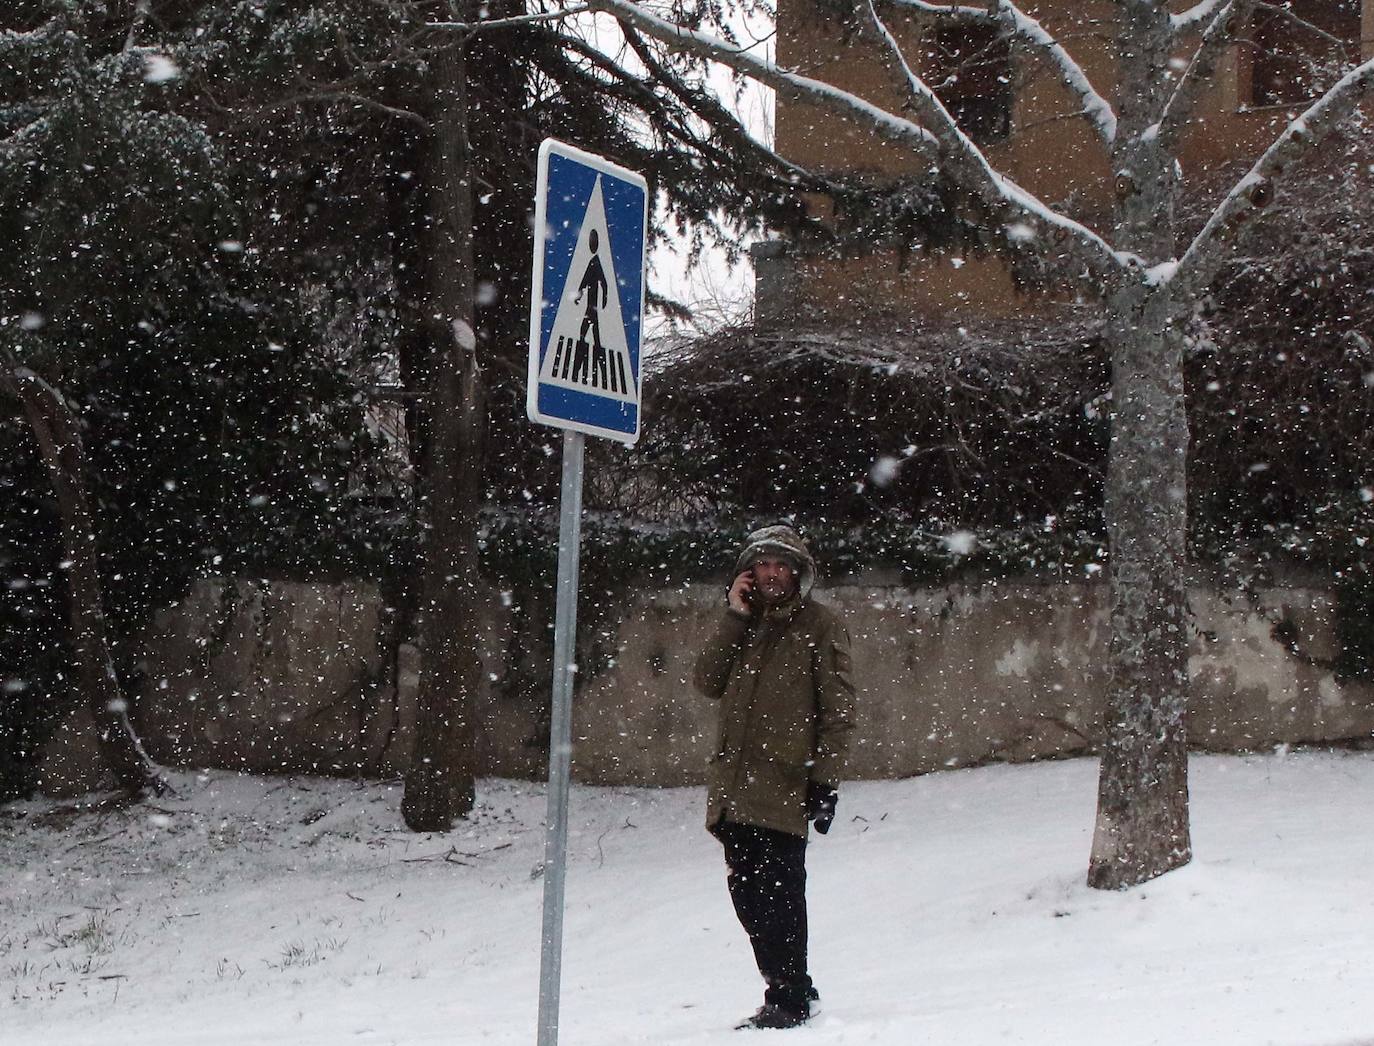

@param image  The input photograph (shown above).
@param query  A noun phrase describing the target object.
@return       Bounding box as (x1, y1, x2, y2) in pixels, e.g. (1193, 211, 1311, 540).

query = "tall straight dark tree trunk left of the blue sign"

(401, 36, 485, 832)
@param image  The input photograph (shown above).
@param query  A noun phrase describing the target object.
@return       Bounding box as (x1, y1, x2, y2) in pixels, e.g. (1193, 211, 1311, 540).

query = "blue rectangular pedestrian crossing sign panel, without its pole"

(526, 139, 649, 443)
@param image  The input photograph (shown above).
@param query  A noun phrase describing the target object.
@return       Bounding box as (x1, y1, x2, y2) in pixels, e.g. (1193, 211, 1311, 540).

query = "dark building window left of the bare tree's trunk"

(929, 26, 1013, 146)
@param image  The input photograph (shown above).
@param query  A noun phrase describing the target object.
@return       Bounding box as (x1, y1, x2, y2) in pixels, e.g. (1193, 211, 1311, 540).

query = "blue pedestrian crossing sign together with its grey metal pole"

(525, 139, 649, 1046)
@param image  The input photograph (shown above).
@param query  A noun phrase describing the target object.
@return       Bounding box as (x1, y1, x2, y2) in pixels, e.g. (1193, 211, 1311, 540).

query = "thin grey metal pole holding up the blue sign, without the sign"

(539, 432, 587, 1046)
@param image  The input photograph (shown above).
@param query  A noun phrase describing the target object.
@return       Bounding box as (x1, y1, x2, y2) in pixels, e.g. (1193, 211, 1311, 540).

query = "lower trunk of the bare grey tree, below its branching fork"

(1088, 289, 1191, 889)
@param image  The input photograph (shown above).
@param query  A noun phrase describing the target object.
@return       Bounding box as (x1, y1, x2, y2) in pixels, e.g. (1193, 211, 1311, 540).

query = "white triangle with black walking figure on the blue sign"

(539, 175, 639, 403)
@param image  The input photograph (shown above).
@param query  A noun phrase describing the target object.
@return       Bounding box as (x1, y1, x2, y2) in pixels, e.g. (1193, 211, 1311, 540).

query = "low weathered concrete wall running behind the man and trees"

(37, 579, 1374, 792)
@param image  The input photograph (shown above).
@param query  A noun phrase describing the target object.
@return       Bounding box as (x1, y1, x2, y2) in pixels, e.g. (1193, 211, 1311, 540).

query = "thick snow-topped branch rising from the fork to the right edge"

(1172, 59, 1374, 294)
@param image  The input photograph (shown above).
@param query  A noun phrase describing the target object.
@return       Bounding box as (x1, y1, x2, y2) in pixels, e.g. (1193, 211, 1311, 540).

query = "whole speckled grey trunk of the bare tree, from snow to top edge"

(1088, 4, 1191, 889)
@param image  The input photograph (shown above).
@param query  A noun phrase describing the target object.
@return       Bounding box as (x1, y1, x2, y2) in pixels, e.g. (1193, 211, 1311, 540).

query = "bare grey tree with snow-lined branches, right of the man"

(577, 0, 1374, 888)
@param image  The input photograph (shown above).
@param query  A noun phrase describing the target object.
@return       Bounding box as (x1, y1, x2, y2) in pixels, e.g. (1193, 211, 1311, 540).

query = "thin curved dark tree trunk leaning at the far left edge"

(0, 368, 166, 794)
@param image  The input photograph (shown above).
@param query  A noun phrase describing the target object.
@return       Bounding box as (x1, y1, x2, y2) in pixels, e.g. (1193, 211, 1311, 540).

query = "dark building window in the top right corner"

(1250, 0, 1360, 106)
